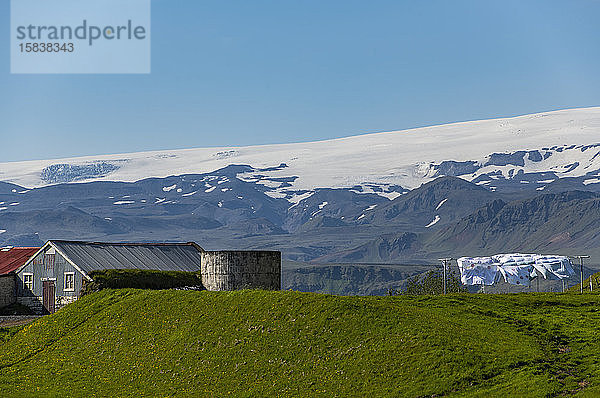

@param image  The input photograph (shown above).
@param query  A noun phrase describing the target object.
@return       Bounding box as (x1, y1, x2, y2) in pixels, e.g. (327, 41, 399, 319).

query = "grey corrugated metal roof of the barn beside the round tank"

(50, 240, 202, 273)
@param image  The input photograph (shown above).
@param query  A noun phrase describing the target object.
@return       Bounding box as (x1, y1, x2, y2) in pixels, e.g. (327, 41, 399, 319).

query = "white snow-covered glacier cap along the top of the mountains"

(0, 107, 600, 199)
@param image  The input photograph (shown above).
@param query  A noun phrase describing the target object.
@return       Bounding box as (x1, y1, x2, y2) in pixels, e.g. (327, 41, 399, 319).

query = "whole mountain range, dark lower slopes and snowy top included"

(0, 108, 600, 290)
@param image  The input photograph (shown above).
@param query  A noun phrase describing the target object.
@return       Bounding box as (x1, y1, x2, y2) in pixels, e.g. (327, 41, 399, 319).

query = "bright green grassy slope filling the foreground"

(0, 289, 600, 397)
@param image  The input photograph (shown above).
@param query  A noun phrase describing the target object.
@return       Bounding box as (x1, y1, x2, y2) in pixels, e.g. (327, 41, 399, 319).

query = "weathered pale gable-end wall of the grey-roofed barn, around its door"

(16, 247, 83, 313)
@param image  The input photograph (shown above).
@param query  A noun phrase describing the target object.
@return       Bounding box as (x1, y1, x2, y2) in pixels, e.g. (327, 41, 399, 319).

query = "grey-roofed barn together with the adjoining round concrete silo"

(13, 240, 281, 313)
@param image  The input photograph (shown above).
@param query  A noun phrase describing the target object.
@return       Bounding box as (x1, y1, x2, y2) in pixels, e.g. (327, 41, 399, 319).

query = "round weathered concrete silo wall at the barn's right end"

(201, 251, 281, 290)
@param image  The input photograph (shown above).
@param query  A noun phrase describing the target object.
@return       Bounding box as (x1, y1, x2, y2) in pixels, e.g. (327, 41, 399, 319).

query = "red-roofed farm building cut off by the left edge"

(0, 247, 39, 308)
